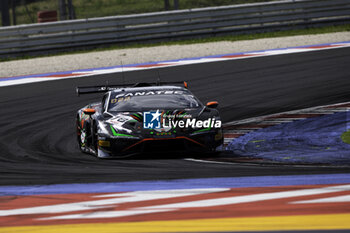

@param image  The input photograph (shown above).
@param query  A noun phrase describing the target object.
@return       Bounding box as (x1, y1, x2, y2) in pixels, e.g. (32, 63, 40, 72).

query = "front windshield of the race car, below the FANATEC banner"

(108, 94, 201, 112)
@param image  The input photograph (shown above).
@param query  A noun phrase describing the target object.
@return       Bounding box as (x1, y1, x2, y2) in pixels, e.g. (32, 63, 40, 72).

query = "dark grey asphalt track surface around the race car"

(0, 48, 350, 185)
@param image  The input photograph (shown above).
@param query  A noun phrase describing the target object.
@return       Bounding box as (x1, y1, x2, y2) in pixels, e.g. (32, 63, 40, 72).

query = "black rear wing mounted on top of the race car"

(76, 81, 188, 96)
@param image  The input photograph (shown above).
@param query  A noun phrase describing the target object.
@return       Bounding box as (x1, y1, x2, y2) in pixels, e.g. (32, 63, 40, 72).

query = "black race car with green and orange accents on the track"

(76, 82, 223, 159)
